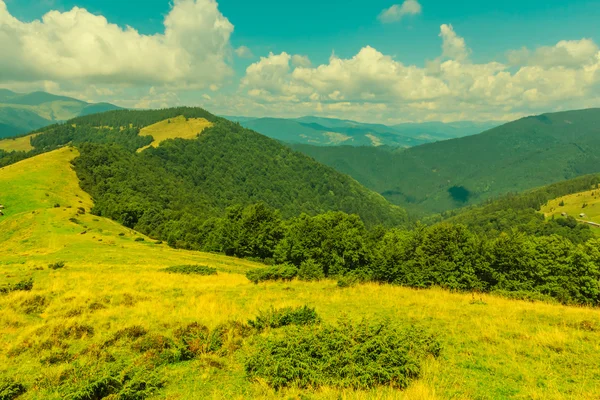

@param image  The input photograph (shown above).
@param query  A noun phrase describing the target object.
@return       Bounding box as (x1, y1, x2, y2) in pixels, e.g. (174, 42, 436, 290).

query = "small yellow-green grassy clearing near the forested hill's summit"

(138, 116, 212, 152)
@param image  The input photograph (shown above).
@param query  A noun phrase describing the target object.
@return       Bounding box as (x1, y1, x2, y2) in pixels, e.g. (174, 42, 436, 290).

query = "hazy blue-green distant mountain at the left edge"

(0, 89, 121, 138)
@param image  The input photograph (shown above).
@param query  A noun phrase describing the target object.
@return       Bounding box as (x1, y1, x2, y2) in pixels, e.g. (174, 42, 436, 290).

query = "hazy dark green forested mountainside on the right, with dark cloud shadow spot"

(293, 109, 600, 213)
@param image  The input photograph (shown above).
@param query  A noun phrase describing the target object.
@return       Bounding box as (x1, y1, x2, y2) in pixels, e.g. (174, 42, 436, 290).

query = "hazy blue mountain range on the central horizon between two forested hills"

(225, 116, 500, 148)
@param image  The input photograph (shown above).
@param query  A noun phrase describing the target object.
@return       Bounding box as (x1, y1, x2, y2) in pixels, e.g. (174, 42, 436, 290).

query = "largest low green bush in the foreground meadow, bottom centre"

(245, 321, 441, 389)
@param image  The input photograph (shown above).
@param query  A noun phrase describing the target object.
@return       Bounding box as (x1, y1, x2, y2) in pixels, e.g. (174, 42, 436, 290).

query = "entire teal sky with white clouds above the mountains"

(0, 0, 600, 123)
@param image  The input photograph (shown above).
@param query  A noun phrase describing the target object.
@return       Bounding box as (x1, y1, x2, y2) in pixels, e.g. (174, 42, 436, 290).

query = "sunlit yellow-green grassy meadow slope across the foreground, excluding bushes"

(0, 148, 600, 400)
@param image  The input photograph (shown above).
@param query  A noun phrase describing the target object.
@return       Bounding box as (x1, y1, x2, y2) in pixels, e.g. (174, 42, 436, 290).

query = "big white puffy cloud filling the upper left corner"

(0, 0, 233, 87)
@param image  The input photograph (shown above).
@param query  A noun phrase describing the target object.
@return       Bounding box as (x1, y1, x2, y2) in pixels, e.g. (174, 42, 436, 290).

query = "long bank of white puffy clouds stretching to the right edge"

(240, 25, 600, 122)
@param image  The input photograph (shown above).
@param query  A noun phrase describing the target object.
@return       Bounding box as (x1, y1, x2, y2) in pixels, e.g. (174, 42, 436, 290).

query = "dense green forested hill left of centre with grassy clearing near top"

(0, 107, 405, 234)
